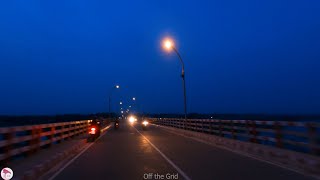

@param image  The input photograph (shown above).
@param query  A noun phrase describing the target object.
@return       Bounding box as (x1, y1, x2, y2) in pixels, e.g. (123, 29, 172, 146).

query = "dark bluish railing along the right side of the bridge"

(152, 118, 320, 155)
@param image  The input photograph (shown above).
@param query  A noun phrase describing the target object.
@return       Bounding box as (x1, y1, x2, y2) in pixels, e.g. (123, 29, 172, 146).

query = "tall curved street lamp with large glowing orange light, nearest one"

(163, 38, 187, 123)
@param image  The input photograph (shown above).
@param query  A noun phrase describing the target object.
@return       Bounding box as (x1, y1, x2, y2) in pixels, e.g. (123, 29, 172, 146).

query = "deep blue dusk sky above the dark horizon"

(0, 0, 320, 115)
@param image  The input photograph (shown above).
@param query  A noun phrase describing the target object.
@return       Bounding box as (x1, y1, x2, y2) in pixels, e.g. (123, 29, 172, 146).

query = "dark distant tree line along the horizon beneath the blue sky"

(0, 113, 320, 127)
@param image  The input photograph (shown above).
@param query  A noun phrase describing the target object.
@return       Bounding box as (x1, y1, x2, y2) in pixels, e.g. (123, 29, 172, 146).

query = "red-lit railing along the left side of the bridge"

(0, 120, 109, 164)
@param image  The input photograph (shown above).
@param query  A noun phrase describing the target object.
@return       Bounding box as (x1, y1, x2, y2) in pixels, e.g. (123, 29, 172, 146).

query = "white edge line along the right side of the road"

(151, 124, 312, 178)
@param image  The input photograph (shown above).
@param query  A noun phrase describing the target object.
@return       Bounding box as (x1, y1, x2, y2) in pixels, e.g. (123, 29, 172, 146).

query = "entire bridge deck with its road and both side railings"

(0, 118, 320, 180)
